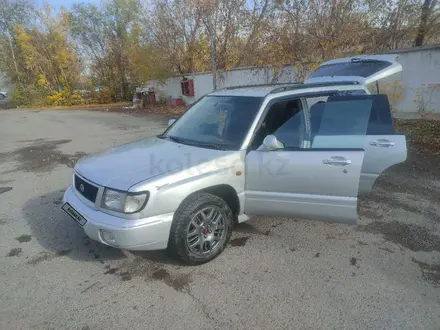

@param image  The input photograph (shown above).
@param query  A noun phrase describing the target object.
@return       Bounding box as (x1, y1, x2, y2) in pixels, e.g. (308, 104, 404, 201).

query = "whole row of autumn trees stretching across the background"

(0, 0, 440, 105)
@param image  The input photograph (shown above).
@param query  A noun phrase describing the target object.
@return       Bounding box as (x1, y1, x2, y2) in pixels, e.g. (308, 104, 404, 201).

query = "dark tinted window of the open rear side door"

(328, 94, 394, 135)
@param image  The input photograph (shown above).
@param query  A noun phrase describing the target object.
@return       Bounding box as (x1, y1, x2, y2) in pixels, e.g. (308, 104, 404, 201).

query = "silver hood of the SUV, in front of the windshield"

(75, 137, 232, 190)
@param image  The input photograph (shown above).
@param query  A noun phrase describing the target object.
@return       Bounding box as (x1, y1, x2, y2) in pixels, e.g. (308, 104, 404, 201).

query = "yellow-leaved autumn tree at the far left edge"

(0, 1, 81, 104)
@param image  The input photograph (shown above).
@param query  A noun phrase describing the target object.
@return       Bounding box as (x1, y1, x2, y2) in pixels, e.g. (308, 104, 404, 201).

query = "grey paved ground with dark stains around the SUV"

(0, 110, 440, 329)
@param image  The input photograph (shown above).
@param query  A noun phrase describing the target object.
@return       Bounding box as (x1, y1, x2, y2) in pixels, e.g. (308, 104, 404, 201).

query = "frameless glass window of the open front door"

(273, 97, 372, 150)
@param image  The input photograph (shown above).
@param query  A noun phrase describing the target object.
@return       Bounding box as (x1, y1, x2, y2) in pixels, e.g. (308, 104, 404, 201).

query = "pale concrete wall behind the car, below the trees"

(142, 45, 440, 118)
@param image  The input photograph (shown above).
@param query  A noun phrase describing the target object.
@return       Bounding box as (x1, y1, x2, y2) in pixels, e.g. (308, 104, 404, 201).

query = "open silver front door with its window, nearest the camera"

(244, 95, 372, 224)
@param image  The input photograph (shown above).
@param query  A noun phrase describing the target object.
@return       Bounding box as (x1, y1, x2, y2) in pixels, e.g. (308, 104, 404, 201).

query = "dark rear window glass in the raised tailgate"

(308, 61, 392, 79)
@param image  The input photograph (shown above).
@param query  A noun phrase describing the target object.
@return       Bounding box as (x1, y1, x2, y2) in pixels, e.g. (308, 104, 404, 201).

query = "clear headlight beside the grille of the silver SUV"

(101, 188, 148, 213)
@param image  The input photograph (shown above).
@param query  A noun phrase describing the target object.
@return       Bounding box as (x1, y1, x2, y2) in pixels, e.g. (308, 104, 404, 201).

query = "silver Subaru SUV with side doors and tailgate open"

(63, 56, 406, 264)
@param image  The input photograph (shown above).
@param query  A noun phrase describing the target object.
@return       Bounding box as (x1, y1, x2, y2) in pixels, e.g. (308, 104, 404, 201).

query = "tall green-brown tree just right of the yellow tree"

(69, 0, 141, 99)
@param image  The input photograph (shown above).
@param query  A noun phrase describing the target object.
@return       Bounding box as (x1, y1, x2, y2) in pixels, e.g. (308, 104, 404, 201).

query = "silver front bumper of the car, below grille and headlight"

(63, 186, 174, 250)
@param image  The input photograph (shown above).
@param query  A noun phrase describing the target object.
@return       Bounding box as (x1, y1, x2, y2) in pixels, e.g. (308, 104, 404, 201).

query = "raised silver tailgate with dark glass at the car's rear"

(304, 55, 402, 85)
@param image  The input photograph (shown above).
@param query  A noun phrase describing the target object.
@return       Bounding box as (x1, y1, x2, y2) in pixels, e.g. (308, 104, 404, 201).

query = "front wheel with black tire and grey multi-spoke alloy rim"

(168, 193, 234, 265)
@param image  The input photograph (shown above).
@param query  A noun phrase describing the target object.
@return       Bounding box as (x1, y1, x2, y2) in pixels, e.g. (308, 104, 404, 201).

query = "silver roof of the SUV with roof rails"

(208, 81, 362, 97)
